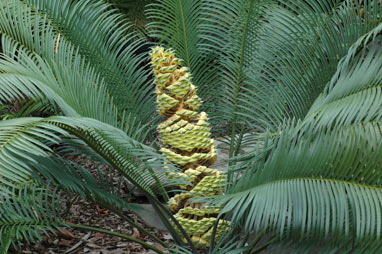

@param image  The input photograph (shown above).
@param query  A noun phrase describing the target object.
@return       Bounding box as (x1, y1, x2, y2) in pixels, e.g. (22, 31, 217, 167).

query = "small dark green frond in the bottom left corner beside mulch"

(0, 186, 65, 246)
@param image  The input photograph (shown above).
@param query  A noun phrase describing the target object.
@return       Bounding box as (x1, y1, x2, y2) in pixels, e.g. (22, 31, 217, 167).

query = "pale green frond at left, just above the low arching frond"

(0, 1, 168, 194)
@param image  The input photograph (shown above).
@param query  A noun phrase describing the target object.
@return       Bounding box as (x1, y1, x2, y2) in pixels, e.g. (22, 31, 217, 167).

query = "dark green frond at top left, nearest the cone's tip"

(25, 0, 153, 116)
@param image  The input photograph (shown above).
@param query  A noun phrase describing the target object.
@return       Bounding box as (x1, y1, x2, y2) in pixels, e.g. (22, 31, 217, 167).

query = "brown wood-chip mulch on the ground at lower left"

(9, 156, 173, 254)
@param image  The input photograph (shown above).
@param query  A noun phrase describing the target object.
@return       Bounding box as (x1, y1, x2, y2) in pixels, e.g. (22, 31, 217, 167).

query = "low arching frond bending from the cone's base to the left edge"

(0, 117, 171, 196)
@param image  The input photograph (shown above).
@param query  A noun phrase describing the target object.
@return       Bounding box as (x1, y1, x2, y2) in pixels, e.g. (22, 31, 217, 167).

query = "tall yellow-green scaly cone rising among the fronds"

(151, 47, 229, 248)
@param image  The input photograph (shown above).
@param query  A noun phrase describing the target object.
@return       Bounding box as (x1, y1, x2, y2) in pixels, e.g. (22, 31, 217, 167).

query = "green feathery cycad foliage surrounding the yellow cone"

(0, 0, 382, 253)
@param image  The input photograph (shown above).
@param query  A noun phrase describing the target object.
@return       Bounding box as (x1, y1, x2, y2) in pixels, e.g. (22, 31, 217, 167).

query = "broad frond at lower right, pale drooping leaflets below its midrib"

(223, 122, 382, 242)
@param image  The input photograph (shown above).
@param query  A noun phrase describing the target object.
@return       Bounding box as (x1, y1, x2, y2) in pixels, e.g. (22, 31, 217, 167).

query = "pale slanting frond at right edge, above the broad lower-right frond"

(304, 25, 382, 129)
